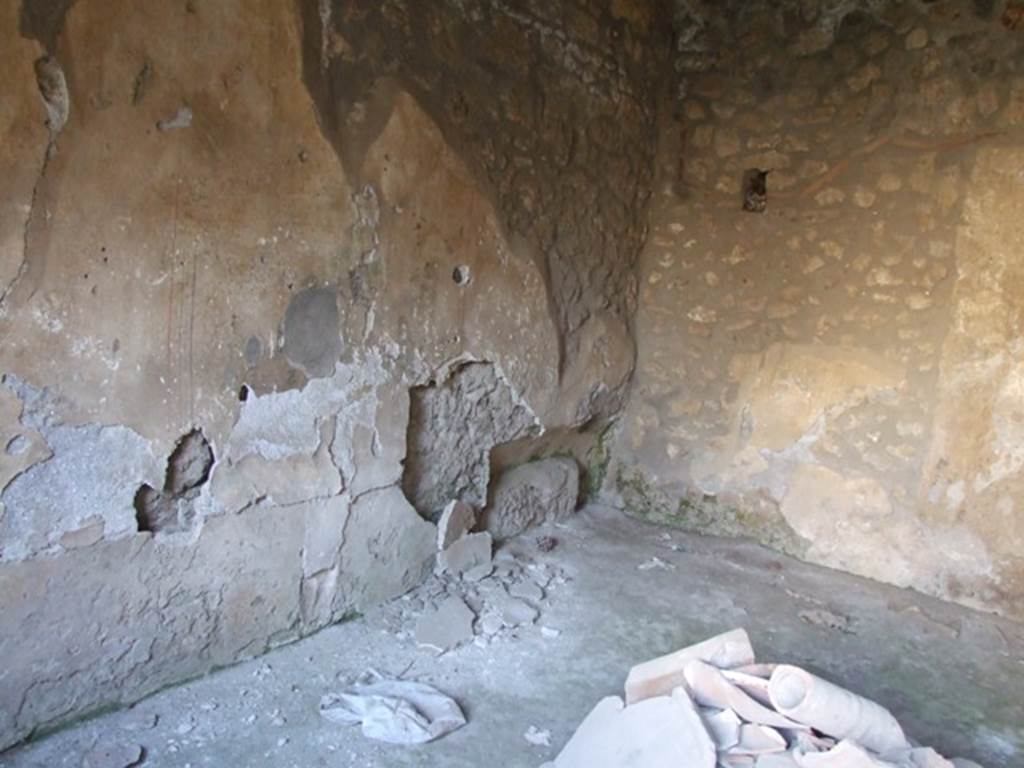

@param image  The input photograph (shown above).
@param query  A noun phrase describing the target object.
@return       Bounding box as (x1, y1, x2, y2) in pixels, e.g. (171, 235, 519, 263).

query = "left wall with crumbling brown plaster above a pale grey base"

(0, 0, 667, 749)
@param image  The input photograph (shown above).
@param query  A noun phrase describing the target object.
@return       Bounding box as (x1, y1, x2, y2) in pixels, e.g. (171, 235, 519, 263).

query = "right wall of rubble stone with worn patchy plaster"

(612, 0, 1024, 616)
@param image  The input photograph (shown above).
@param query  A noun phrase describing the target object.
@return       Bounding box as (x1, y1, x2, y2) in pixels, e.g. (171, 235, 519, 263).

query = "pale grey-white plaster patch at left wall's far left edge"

(0, 376, 162, 560)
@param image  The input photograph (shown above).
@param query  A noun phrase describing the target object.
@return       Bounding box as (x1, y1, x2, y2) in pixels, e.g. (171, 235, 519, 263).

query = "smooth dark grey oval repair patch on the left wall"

(282, 288, 341, 378)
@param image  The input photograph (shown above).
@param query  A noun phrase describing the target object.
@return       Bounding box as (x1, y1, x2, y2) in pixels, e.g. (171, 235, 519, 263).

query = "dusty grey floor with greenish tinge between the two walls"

(0, 508, 1024, 768)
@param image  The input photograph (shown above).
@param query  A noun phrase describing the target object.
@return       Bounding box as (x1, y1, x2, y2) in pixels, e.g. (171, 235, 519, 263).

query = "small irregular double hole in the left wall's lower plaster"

(135, 429, 213, 534)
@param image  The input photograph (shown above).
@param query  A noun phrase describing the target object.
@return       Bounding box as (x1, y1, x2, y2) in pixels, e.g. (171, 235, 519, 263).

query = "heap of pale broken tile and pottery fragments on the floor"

(546, 630, 979, 768)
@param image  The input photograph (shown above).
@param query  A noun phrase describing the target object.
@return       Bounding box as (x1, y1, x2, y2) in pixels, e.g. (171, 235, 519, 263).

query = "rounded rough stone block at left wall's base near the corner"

(484, 458, 580, 540)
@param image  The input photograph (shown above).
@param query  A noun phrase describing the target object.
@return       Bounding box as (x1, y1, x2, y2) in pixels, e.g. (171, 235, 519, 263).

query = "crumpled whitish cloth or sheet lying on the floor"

(319, 676, 466, 744)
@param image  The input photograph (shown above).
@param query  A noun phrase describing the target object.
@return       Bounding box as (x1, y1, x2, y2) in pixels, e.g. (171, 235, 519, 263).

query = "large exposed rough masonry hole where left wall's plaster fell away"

(402, 362, 537, 519)
